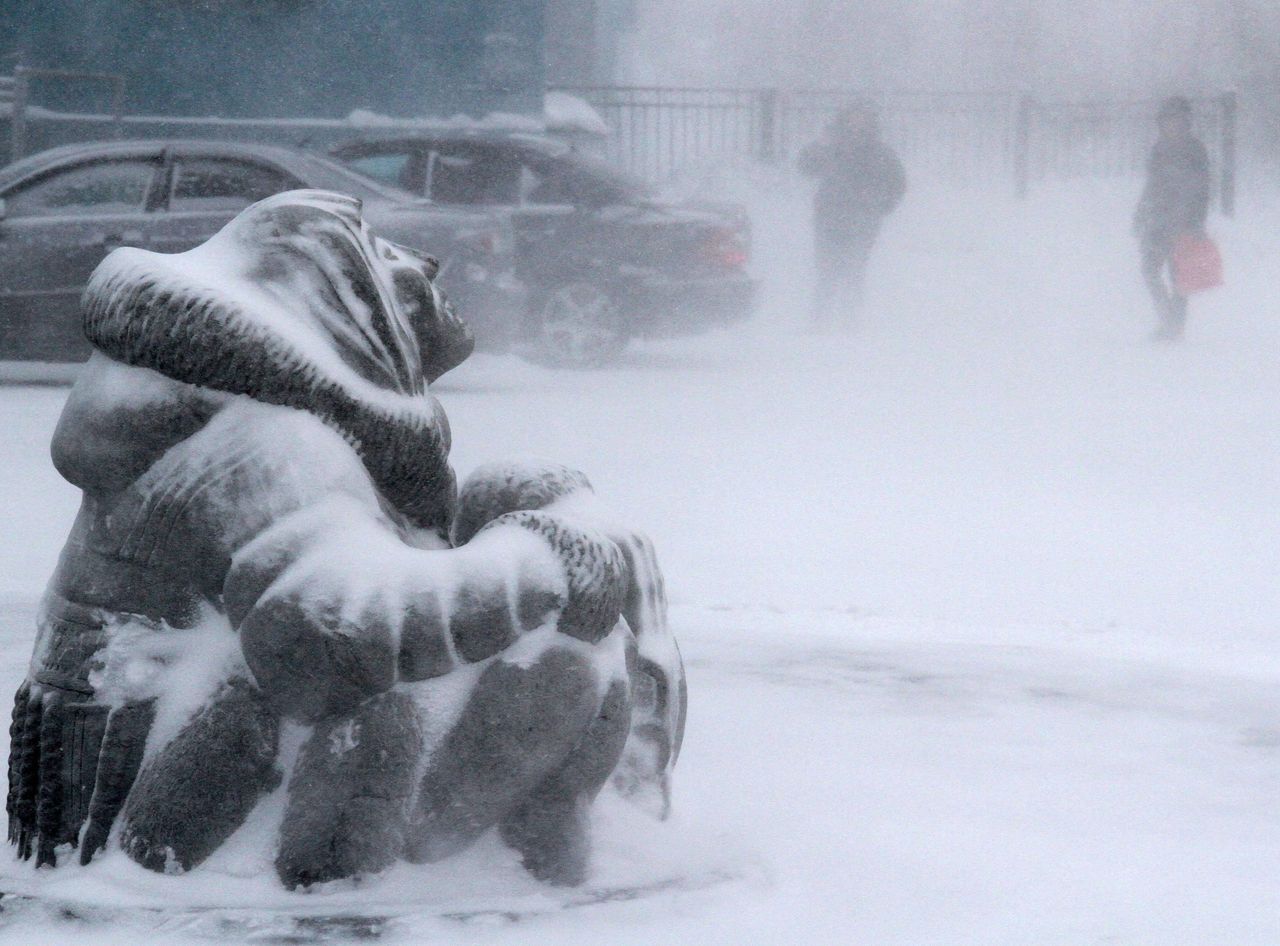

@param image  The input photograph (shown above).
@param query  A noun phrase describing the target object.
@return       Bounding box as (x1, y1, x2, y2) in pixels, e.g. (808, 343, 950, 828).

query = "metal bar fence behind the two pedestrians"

(559, 86, 1236, 212)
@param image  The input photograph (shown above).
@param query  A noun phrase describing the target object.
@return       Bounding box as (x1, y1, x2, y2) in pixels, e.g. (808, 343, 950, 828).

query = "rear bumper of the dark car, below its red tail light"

(618, 275, 758, 335)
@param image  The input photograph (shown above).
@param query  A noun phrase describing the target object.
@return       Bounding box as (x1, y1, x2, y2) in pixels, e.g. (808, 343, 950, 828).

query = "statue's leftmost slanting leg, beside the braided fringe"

(120, 680, 280, 873)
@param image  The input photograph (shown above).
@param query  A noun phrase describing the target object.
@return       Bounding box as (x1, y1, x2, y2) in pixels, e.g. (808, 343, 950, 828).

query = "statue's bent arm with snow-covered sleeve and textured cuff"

(224, 498, 626, 721)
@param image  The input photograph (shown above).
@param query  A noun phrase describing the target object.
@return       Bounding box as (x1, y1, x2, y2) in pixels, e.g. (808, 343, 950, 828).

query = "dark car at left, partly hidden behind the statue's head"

(0, 141, 527, 379)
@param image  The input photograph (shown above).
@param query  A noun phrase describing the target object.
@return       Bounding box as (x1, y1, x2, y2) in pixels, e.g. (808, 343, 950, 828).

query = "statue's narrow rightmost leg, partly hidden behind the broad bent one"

(500, 680, 631, 885)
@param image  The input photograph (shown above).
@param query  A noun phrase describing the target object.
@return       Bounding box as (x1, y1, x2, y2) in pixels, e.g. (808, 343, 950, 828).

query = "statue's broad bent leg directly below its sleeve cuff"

(406, 644, 600, 863)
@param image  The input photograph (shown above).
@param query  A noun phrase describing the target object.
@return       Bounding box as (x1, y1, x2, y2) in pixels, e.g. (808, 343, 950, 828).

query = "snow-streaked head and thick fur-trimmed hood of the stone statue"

(83, 191, 474, 531)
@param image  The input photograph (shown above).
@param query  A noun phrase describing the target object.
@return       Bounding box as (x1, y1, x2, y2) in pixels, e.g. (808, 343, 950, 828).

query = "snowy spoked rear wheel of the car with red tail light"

(536, 283, 627, 367)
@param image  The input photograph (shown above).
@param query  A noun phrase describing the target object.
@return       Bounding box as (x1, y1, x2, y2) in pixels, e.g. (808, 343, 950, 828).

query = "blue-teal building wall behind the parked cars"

(0, 0, 547, 118)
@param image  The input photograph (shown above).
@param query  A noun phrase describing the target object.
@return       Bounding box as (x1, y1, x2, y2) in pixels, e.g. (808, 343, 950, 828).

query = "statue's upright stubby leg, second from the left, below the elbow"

(275, 693, 422, 890)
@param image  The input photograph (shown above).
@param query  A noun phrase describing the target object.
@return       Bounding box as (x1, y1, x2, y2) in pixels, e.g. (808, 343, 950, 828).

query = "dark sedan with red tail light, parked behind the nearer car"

(330, 128, 754, 362)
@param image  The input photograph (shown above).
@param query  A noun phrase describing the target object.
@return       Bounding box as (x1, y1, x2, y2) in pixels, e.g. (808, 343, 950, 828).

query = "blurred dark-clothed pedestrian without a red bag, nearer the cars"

(800, 105, 906, 328)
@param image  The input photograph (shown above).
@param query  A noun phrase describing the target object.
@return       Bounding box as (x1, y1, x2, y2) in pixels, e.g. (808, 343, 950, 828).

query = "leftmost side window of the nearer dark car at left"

(5, 159, 156, 218)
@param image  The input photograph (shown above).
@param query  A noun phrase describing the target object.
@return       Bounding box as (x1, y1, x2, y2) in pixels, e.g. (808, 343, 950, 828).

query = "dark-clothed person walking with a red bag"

(1133, 96, 1210, 341)
